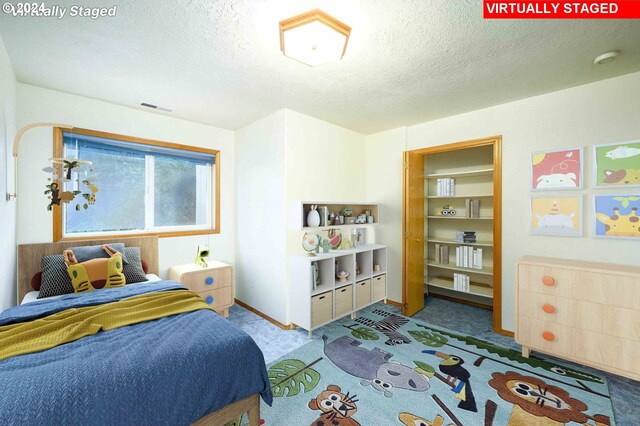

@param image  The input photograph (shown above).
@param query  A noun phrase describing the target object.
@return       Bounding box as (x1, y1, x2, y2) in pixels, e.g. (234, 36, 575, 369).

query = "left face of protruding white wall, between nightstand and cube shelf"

(235, 110, 287, 323)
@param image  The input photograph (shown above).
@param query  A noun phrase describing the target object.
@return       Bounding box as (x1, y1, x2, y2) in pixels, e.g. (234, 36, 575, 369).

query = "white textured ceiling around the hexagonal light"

(0, 0, 640, 134)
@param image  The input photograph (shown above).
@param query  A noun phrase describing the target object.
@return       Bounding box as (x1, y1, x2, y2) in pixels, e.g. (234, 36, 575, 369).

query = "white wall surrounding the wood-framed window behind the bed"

(17, 84, 235, 276)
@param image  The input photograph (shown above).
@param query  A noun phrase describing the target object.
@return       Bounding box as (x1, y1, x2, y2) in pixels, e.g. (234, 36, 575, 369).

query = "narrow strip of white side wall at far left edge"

(0, 39, 16, 311)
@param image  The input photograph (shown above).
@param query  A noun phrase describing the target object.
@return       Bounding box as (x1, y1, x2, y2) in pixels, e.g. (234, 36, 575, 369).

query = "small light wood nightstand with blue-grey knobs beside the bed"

(169, 260, 235, 317)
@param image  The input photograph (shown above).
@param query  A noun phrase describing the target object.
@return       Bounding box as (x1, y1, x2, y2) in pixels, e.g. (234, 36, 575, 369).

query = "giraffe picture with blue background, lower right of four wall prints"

(593, 194, 640, 240)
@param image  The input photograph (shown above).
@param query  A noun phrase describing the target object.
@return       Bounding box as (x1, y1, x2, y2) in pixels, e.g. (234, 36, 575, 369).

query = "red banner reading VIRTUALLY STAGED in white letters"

(483, 0, 640, 19)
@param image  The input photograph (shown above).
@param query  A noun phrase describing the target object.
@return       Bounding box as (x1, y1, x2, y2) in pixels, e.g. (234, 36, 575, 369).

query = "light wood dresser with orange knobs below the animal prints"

(515, 256, 640, 380)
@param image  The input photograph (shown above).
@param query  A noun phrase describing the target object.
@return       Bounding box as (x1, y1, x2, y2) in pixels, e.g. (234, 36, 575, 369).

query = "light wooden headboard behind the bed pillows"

(18, 237, 158, 304)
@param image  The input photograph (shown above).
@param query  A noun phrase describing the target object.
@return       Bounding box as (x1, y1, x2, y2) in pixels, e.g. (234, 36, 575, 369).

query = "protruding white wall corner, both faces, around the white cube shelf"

(236, 109, 367, 324)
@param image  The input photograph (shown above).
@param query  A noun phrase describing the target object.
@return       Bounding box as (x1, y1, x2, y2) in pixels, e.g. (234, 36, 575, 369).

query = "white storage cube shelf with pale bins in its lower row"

(289, 244, 387, 336)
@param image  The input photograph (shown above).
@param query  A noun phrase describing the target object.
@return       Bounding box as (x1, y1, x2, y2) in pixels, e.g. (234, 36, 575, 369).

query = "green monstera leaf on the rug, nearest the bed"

(268, 358, 322, 398)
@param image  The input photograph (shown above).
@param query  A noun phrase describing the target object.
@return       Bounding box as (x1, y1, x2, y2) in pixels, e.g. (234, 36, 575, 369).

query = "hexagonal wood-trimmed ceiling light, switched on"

(280, 9, 351, 67)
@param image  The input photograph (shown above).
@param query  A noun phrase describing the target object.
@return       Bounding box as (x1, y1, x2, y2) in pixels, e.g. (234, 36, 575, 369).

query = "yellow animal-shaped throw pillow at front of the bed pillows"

(62, 244, 125, 293)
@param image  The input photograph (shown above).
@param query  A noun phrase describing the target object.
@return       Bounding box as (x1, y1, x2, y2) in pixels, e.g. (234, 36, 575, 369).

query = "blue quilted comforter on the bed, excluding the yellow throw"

(0, 281, 272, 425)
